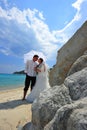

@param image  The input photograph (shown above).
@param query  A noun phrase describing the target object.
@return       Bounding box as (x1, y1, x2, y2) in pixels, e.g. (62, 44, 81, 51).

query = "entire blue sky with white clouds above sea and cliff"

(0, 0, 87, 73)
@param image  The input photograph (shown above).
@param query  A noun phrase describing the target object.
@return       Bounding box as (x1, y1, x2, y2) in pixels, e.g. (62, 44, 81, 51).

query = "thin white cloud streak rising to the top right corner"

(53, 0, 87, 44)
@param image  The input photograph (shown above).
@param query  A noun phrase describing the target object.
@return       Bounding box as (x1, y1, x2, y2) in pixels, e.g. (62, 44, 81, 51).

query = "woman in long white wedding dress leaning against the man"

(26, 58, 50, 102)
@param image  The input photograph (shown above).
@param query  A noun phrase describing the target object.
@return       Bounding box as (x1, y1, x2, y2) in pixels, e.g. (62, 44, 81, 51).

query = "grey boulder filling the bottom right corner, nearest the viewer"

(44, 98, 87, 130)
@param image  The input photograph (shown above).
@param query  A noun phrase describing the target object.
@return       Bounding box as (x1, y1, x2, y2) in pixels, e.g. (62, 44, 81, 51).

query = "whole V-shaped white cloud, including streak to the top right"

(0, 0, 87, 64)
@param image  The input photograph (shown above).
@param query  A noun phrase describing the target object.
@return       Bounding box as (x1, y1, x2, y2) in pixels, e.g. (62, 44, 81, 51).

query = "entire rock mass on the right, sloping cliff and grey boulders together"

(23, 22, 87, 130)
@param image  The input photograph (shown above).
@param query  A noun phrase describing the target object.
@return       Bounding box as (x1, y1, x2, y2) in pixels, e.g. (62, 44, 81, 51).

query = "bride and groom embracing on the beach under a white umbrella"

(22, 55, 50, 103)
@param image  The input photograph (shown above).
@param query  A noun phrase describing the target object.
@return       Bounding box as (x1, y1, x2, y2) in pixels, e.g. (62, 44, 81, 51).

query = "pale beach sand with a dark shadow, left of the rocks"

(0, 87, 32, 130)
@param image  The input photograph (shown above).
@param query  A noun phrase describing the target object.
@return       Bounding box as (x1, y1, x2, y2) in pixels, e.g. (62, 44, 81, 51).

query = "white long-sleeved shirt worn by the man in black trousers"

(25, 60, 37, 76)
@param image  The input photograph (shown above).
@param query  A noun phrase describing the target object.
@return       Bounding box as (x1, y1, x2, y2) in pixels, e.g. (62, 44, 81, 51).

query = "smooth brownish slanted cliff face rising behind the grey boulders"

(49, 21, 87, 86)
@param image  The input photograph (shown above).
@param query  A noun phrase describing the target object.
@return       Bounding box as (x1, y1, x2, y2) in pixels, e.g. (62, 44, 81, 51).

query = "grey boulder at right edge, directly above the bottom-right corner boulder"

(64, 68, 87, 100)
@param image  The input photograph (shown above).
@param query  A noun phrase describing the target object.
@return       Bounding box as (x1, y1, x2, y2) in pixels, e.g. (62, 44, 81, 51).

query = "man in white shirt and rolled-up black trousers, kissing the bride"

(22, 55, 39, 100)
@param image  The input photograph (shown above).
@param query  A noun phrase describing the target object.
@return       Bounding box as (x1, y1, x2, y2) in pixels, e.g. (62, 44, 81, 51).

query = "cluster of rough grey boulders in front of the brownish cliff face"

(25, 68, 87, 130)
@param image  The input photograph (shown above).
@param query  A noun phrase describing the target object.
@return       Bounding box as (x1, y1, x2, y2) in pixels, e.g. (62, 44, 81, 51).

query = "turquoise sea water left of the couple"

(0, 74, 25, 90)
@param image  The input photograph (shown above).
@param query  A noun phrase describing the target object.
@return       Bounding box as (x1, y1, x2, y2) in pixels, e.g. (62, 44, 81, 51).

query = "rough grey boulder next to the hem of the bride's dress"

(32, 85, 72, 130)
